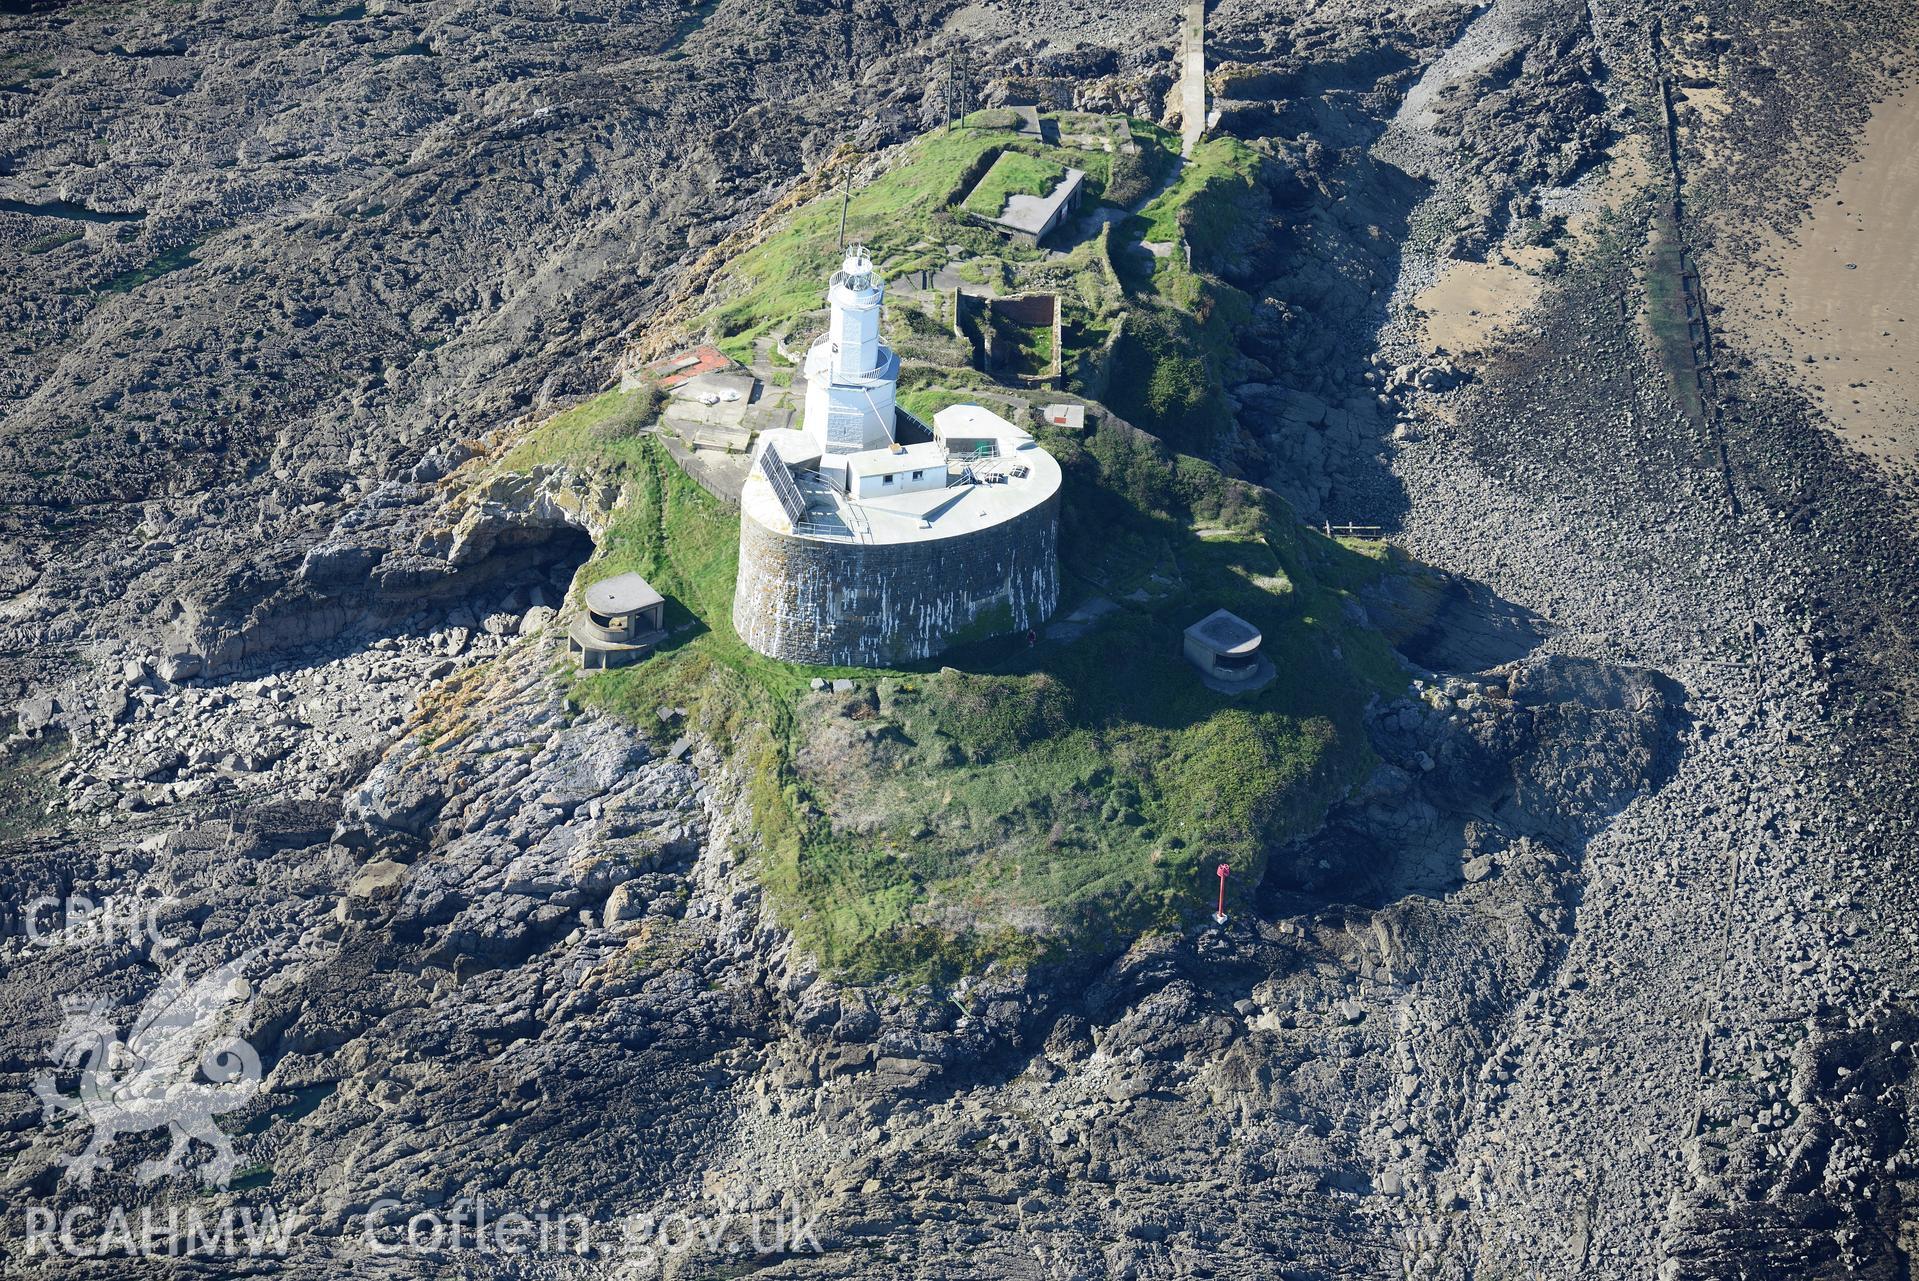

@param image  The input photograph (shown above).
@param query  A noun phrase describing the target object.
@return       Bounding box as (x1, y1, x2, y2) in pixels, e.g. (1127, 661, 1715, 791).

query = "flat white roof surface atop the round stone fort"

(739, 405, 1061, 543)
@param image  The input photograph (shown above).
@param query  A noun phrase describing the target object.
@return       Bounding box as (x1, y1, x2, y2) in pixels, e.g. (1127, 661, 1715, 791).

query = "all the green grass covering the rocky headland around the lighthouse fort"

(456, 117, 1401, 976)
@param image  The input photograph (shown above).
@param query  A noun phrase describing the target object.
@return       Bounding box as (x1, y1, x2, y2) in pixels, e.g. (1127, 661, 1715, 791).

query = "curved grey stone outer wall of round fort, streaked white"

(733, 491, 1059, 667)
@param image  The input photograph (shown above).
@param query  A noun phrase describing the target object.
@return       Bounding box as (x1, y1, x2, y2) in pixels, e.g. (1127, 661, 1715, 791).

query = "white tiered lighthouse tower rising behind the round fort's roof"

(804, 245, 900, 474)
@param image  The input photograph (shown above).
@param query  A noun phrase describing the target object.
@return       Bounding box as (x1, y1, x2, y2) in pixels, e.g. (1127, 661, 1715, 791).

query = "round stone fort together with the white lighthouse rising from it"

(733, 247, 1061, 667)
